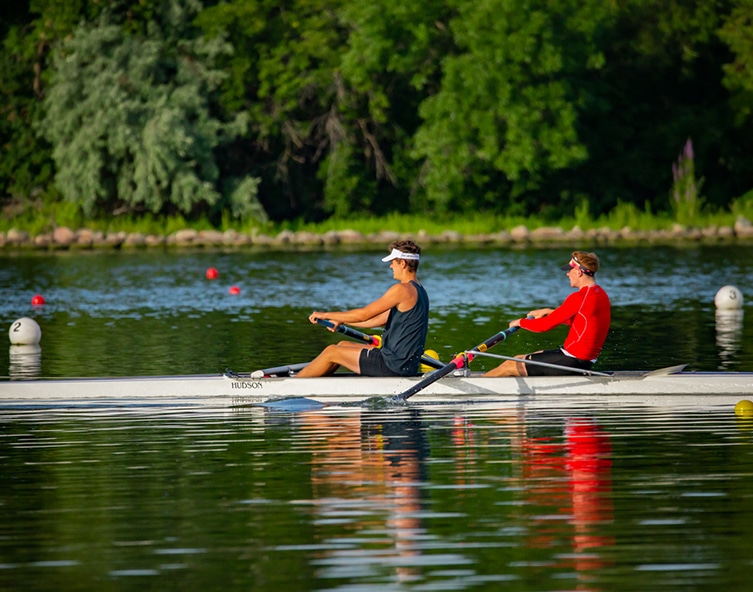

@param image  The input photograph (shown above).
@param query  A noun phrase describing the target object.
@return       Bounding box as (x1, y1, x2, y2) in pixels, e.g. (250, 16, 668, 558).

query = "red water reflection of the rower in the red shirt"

(444, 409, 615, 590)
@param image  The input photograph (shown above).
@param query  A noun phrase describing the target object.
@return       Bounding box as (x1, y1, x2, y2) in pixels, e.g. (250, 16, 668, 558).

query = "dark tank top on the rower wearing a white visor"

(382, 280, 429, 376)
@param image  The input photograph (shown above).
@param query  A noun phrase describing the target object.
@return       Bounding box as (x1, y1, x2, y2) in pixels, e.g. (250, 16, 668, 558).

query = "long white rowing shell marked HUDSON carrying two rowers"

(0, 366, 753, 409)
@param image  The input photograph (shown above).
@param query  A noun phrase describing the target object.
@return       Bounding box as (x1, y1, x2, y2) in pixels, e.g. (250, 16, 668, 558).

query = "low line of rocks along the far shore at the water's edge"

(0, 217, 753, 250)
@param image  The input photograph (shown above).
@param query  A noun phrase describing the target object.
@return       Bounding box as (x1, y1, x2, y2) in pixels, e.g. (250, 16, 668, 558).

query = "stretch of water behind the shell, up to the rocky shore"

(0, 247, 753, 376)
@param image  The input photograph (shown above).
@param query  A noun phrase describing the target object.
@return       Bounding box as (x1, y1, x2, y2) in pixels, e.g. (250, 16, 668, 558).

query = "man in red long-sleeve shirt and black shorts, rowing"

(484, 251, 611, 376)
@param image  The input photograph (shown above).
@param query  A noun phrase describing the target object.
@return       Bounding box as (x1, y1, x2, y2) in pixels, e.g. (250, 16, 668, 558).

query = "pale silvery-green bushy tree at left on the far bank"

(40, 0, 265, 220)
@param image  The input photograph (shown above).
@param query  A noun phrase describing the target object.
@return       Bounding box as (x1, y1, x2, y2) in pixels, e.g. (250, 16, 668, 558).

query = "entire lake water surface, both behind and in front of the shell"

(0, 247, 753, 592)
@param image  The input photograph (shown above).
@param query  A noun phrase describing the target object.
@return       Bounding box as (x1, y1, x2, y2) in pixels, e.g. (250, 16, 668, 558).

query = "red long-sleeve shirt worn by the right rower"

(520, 284, 611, 360)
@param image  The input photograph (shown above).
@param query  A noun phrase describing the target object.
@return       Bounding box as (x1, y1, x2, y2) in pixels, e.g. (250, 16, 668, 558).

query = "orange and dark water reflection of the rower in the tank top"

(301, 410, 428, 582)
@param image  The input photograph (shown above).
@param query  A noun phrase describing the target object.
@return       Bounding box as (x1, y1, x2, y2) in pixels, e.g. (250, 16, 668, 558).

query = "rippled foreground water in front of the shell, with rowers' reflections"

(0, 405, 753, 591)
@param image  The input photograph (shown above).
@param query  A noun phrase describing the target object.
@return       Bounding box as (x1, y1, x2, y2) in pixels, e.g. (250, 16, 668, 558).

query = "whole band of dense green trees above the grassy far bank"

(0, 0, 753, 227)
